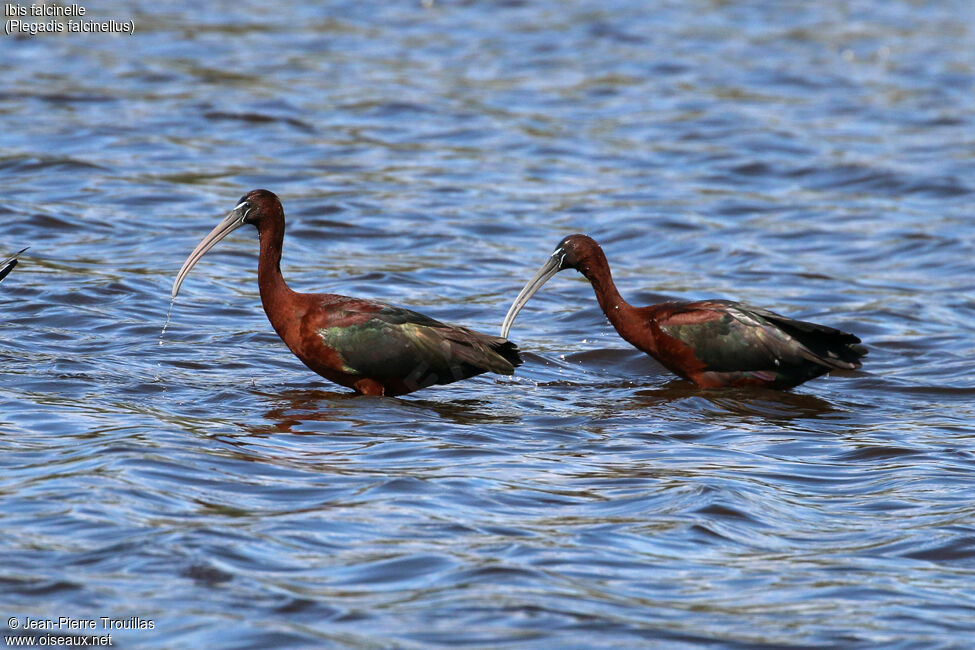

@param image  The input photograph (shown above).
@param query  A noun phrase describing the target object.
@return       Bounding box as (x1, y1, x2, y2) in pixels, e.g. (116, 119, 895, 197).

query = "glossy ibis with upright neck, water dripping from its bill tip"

(173, 185, 521, 396)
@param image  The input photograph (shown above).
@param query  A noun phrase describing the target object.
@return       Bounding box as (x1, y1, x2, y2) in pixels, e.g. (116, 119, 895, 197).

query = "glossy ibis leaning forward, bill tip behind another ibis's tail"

(501, 235, 867, 388)
